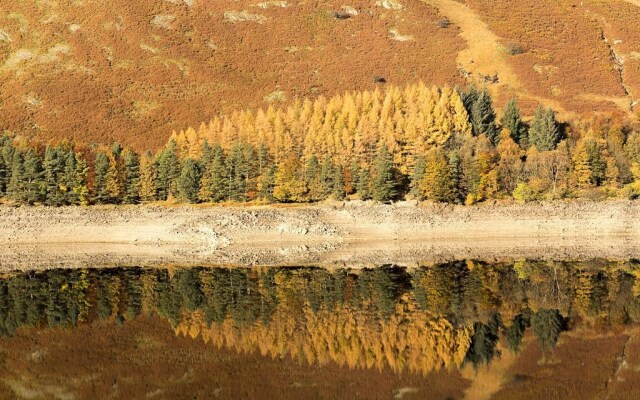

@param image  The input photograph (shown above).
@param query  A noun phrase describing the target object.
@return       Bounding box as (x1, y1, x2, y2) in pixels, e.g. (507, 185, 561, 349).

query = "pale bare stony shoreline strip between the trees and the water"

(0, 201, 640, 271)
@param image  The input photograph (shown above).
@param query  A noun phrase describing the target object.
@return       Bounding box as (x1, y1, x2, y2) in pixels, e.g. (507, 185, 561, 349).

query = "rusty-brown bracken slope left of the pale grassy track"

(0, 0, 464, 149)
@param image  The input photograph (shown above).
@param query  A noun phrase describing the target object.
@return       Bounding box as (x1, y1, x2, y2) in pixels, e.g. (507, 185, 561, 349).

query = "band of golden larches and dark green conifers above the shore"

(0, 83, 640, 206)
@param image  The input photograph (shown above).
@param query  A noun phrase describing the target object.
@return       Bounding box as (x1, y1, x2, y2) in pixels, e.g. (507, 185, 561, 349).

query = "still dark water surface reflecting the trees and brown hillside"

(0, 260, 640, 399)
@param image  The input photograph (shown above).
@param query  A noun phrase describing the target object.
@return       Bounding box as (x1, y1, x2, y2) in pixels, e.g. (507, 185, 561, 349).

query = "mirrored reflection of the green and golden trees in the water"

(0, 260, 640, 374)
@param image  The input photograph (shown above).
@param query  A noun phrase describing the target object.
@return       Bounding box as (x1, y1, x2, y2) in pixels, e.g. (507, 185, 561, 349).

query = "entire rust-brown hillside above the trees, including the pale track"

(0, 0, 640, 149)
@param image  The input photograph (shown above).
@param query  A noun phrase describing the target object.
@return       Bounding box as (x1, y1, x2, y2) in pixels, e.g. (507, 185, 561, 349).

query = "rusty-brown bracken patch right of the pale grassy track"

(456, 0, 635, 117)
